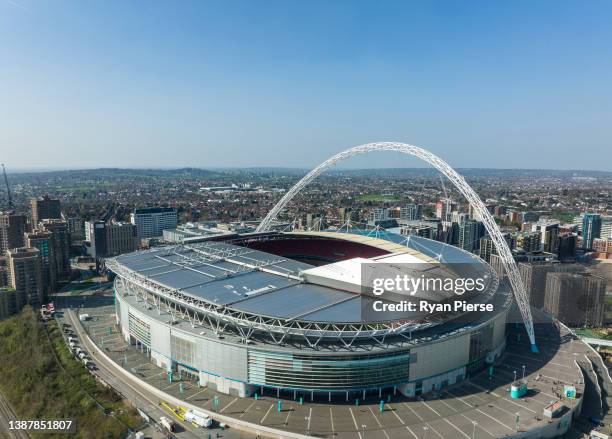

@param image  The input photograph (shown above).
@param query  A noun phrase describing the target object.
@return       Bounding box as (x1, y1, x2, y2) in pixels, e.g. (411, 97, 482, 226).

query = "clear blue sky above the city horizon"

(0, 0, 612, 171)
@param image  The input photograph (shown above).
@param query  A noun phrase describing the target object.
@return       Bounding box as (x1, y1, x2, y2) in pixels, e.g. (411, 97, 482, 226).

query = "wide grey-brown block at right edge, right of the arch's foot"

(544, 273, 606, 327)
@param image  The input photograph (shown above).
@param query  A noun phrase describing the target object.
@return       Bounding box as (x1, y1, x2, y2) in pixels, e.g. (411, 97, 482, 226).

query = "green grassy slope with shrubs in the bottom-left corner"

(0, 307, 141, 438)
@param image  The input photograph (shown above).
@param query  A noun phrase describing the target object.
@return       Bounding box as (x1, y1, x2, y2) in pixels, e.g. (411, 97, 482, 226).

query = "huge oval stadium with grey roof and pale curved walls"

(107, 230, 512, 400)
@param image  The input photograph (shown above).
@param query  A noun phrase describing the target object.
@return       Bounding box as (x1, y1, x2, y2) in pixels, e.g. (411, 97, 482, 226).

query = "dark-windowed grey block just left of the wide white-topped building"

(85, 221, 139, 259)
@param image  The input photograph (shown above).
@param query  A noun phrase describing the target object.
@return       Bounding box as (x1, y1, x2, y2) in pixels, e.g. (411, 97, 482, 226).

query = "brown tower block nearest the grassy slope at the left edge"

(7, 247, 44, 312)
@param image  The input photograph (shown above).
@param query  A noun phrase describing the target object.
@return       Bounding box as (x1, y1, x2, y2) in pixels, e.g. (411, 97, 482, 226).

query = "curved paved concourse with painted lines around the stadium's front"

(53, 286, 587, 439)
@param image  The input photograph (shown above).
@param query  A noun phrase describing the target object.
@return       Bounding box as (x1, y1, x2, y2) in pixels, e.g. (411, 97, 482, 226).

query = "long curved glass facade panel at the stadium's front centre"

(248, 350, 410, 391)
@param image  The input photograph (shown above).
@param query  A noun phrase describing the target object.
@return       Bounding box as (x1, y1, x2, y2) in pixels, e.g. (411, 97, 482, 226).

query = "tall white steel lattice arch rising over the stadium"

(257, 142, 538, 352)
